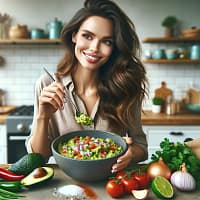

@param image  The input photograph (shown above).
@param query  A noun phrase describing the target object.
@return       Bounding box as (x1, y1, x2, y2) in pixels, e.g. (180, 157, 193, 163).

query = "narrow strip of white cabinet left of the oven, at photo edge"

(0, 125, 7, 164)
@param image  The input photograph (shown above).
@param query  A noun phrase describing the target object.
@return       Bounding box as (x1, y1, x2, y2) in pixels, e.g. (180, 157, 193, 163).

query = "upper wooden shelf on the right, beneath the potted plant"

(142, 37, 200, 43)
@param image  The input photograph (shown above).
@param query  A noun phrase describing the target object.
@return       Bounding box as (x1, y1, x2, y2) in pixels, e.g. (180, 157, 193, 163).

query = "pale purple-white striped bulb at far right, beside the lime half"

(170, 163, 196, 191)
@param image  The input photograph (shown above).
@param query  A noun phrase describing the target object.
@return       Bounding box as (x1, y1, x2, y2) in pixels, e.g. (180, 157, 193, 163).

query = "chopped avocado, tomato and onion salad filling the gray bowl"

(58, 136, 123, 160)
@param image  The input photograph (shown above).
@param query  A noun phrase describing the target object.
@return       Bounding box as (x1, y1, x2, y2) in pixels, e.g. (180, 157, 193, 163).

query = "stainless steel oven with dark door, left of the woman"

(6, 105, 34, 163)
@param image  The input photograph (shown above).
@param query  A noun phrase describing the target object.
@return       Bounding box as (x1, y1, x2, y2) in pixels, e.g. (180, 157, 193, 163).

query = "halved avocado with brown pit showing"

(21, 167, 54, 186)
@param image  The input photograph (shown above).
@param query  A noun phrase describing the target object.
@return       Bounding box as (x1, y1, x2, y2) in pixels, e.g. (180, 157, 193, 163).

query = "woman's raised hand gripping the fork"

(38, 82, 65, 118)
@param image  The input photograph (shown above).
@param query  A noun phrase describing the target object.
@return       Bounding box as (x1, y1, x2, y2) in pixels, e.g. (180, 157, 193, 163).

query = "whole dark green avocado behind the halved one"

(8, 153, 45, 176)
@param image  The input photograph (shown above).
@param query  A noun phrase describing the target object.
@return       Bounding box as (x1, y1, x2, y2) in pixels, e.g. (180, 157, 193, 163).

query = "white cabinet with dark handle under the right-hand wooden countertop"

(143, 125, 200, 162)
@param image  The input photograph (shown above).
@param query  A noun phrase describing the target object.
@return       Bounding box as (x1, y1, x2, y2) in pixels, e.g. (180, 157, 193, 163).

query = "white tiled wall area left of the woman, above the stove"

(0, 45, 63, 105)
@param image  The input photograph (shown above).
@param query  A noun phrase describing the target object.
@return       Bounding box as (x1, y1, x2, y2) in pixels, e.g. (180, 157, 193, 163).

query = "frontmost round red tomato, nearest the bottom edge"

(106, 179, 124, 198)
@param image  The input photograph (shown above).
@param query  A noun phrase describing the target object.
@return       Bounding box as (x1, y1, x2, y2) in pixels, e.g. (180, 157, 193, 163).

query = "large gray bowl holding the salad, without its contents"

(51, 130, 127, 182)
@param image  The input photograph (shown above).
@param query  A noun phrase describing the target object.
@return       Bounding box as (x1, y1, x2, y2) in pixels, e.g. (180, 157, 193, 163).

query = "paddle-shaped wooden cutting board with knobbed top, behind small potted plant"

(155, 81, 172, 112)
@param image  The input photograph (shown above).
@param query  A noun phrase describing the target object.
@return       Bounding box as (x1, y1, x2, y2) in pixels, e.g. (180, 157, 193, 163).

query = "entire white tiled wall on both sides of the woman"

(0, 45, 200, 109)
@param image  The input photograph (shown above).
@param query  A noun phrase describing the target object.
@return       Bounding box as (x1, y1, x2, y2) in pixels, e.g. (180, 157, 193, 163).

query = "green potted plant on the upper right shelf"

(162, 16, 177, 37)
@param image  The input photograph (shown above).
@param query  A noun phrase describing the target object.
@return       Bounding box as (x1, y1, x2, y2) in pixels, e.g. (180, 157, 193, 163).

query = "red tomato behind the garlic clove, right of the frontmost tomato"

(122, 177, 139, 193)
